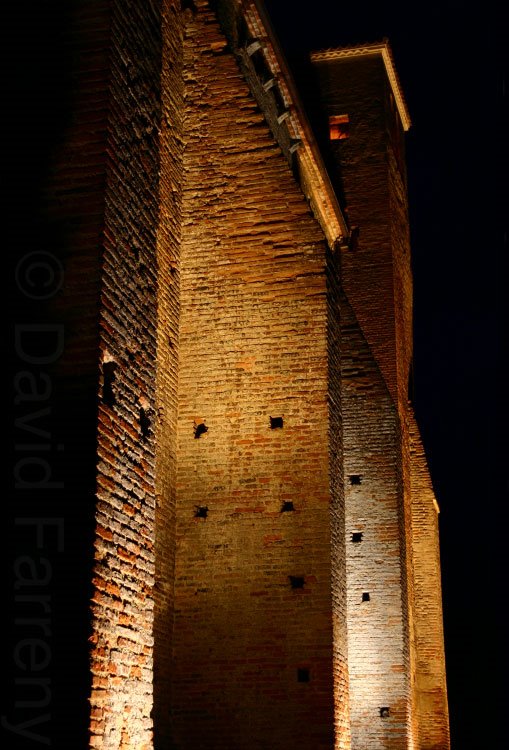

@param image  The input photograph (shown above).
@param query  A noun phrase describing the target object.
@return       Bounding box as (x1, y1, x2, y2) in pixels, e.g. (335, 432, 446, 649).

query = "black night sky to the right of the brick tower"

(265, 0, 507, 750)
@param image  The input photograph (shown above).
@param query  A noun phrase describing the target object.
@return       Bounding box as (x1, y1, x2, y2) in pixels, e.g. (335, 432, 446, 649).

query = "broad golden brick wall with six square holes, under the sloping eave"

(173, 3, 347, 748)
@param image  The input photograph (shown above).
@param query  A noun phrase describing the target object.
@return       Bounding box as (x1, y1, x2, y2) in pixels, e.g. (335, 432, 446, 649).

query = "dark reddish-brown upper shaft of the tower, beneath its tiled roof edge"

(314, 55, 412, 414)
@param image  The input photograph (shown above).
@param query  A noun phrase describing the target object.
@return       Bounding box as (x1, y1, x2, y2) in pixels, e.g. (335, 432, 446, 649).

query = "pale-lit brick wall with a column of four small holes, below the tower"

(341, 299, 410, 749)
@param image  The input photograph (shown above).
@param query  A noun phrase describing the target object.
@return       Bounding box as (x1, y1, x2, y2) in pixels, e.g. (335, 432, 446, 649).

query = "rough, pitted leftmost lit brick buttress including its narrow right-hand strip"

(91, 2, 182, 748)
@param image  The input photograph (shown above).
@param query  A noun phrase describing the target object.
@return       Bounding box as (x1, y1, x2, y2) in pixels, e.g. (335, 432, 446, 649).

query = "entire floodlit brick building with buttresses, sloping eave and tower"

(35, 0, 449, 750)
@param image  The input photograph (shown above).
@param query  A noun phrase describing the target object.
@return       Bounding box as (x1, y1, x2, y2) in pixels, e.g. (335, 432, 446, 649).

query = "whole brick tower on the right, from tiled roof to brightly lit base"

(311, 41, 449, 750)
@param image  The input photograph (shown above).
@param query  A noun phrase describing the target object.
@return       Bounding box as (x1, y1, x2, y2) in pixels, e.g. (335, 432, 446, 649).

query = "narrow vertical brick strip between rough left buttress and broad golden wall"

(153, 0, 184, 750)
